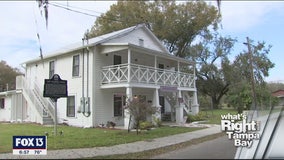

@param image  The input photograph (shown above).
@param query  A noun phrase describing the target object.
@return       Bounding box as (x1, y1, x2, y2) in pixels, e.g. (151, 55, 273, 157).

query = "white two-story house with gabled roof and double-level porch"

(0, 24, 199, 128)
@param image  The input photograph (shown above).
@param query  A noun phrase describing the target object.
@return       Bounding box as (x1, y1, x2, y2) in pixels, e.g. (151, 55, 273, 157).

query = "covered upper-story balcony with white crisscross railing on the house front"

(99, 44, 196, 91)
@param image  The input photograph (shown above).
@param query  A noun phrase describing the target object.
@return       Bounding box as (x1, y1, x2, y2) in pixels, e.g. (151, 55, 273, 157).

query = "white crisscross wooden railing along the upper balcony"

(101, 64, 194, 88)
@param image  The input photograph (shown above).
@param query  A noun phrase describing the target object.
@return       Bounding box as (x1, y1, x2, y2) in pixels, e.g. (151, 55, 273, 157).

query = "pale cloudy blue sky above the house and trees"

(0, 1, 284, 82)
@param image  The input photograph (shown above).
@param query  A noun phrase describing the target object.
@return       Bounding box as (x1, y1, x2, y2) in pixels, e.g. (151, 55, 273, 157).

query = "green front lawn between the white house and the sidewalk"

(0, 123, 202, 153)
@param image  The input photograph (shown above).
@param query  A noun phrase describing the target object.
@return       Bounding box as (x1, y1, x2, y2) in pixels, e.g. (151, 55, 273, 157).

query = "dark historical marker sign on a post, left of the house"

(43, 74, 68, 135)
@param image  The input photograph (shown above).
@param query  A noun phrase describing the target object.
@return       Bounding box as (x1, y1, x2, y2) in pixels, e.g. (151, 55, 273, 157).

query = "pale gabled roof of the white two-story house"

(23, 24, 169, 64)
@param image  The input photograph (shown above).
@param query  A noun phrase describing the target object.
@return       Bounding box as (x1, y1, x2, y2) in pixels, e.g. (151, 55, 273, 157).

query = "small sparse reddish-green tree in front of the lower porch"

(125, 96, 156, 134)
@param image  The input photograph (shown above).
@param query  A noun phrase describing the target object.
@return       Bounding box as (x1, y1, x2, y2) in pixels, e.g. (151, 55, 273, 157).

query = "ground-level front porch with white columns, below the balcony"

(98, 84, 199, 129)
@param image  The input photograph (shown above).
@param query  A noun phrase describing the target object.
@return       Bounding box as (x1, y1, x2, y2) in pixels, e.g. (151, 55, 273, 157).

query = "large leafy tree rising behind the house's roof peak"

(90, 0, 220, 57)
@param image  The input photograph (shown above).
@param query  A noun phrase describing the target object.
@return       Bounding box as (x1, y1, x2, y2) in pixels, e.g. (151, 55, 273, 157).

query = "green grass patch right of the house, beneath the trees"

(197, 109, 238, 124)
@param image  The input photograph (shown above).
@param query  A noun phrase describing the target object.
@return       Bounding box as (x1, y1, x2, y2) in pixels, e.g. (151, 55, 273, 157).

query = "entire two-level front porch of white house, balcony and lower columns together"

(98, 44, 199, 128)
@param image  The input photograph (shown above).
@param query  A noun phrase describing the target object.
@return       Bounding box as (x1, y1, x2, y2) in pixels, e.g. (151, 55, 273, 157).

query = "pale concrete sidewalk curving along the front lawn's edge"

(0, 125, 221, 159)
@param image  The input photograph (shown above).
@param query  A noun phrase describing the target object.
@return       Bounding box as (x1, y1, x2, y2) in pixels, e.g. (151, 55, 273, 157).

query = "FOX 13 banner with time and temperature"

(13, 136, 47, 155)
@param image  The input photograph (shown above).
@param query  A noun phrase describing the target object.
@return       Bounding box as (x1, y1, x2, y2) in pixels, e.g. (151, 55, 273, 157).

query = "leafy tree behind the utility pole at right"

(227, 40, 274, 109)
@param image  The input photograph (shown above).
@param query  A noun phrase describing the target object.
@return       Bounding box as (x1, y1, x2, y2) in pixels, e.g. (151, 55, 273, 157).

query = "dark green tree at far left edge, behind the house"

(0, 61, 22, 92)
